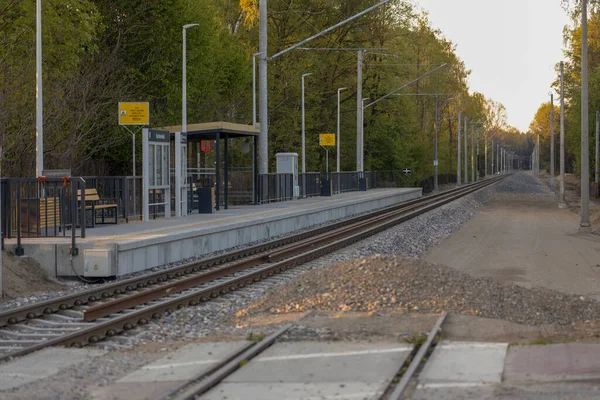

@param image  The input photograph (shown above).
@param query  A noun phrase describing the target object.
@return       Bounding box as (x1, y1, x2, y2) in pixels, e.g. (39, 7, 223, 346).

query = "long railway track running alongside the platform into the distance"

(0, 176, 505, 361)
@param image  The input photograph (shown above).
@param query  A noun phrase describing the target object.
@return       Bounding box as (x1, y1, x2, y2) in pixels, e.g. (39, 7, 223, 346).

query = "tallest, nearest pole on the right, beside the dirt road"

(579, 0, 592, 233)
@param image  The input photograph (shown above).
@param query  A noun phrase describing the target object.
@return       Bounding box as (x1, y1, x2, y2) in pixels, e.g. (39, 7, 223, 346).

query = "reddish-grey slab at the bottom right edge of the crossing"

(504, 343, 600, 382)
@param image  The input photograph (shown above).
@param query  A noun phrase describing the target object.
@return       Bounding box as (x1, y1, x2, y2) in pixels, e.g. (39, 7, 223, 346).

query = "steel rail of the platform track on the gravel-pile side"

(0, 176, 505, 361)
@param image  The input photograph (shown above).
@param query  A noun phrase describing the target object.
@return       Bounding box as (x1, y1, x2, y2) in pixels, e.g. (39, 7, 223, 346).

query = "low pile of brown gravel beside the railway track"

(241, 256, 600, 326)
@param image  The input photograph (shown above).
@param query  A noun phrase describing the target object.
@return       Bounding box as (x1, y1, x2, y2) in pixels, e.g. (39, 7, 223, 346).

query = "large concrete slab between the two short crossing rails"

(202, 342, 412, 400)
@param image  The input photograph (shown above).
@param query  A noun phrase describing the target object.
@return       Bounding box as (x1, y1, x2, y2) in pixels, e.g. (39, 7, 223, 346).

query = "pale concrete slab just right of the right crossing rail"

(419, 341, 508, 388)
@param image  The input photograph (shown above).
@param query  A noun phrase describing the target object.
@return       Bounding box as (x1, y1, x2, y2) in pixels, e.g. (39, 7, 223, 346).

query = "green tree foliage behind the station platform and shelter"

(0, 0, 510, 180)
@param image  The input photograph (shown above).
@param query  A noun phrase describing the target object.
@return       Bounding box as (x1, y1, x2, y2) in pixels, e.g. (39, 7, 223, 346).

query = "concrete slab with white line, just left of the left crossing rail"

(117, 341, 249, 383)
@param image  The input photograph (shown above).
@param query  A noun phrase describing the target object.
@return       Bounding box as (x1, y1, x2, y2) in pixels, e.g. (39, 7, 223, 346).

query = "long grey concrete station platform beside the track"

(5, 188, 422, 277)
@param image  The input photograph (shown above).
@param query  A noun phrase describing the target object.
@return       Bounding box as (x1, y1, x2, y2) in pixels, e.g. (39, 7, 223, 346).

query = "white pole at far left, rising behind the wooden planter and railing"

(35, 0, 44, 176)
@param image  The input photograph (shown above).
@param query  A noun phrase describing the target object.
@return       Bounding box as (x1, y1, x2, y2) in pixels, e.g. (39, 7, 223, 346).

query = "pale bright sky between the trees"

(414, 0, 569, 132)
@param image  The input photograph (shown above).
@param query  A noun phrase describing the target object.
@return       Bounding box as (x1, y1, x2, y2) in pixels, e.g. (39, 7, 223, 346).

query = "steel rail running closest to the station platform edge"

(0, 178, 493, 327)
